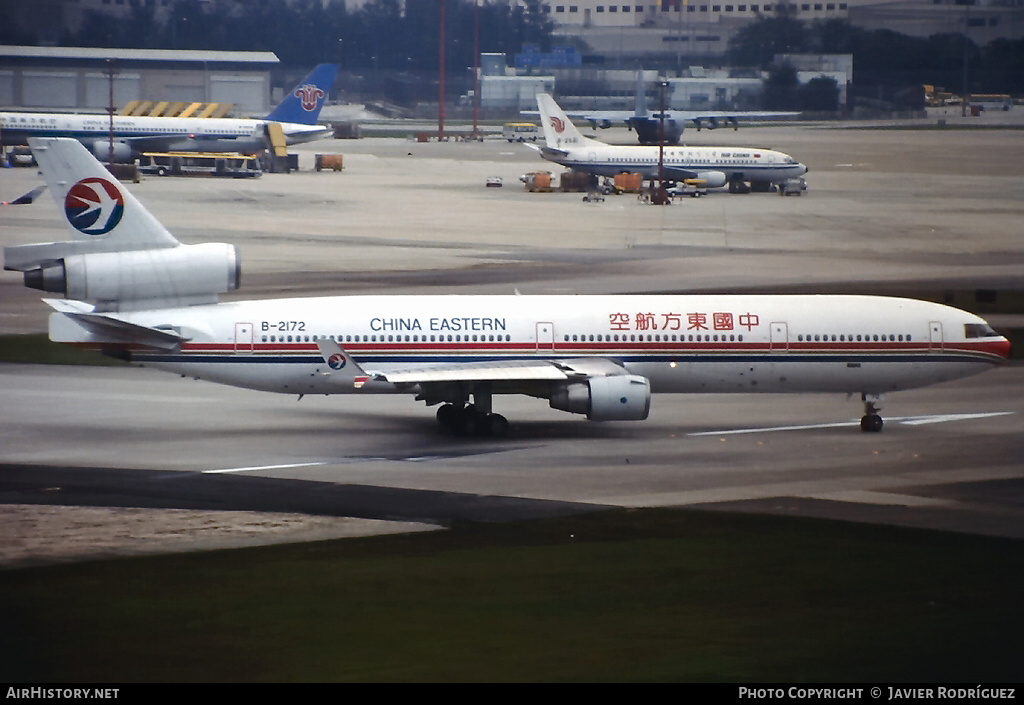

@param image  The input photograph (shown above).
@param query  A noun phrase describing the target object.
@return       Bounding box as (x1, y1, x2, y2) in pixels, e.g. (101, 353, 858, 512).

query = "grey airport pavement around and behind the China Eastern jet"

(0, 119, 1024, 557)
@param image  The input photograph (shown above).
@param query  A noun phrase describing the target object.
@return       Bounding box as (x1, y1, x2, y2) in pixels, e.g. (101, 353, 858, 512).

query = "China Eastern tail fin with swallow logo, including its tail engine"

(4, 137, 240, 310)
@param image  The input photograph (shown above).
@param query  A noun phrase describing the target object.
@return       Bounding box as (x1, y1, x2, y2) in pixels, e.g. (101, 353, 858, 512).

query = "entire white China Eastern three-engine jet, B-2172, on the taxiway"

(4, 138, 1010, 434)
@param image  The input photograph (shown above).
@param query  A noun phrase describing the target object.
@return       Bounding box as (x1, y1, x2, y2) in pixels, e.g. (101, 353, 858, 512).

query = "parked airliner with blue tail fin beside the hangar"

(0, 64, 338, 162)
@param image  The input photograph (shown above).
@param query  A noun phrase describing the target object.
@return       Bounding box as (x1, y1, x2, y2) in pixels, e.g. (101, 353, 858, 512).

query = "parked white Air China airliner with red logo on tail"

(530, 93, 807, 192)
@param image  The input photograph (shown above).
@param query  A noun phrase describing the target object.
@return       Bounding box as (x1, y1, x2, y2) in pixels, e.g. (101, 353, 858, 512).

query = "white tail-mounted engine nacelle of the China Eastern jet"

(25, 243, 242, 302)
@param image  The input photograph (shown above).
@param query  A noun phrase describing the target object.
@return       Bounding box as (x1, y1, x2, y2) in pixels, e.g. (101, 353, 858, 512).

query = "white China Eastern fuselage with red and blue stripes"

(59, 295, 1009, 395)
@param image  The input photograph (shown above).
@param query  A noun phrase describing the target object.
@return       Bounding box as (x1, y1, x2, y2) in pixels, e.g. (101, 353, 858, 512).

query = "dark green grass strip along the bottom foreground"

(0, 509, 1024, 683)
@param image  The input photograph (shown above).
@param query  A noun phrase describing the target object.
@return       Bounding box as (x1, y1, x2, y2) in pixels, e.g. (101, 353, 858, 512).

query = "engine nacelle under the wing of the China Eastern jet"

(549, 375, 650, 421)
